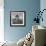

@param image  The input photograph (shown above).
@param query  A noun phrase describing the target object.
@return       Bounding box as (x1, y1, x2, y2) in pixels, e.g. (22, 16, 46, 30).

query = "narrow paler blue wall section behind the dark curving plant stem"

(40, 0, 46, 27)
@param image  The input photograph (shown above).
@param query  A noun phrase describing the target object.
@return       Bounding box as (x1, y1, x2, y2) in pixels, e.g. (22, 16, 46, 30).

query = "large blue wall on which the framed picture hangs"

(4, 0, 40, 41)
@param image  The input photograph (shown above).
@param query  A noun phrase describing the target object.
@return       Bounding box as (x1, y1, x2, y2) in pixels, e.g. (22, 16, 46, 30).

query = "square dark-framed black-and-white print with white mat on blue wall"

(10, 11, 26, 26)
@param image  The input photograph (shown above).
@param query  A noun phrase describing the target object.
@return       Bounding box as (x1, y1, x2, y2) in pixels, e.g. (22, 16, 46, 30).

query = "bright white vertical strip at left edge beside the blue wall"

(0, 0, 4, 42)
